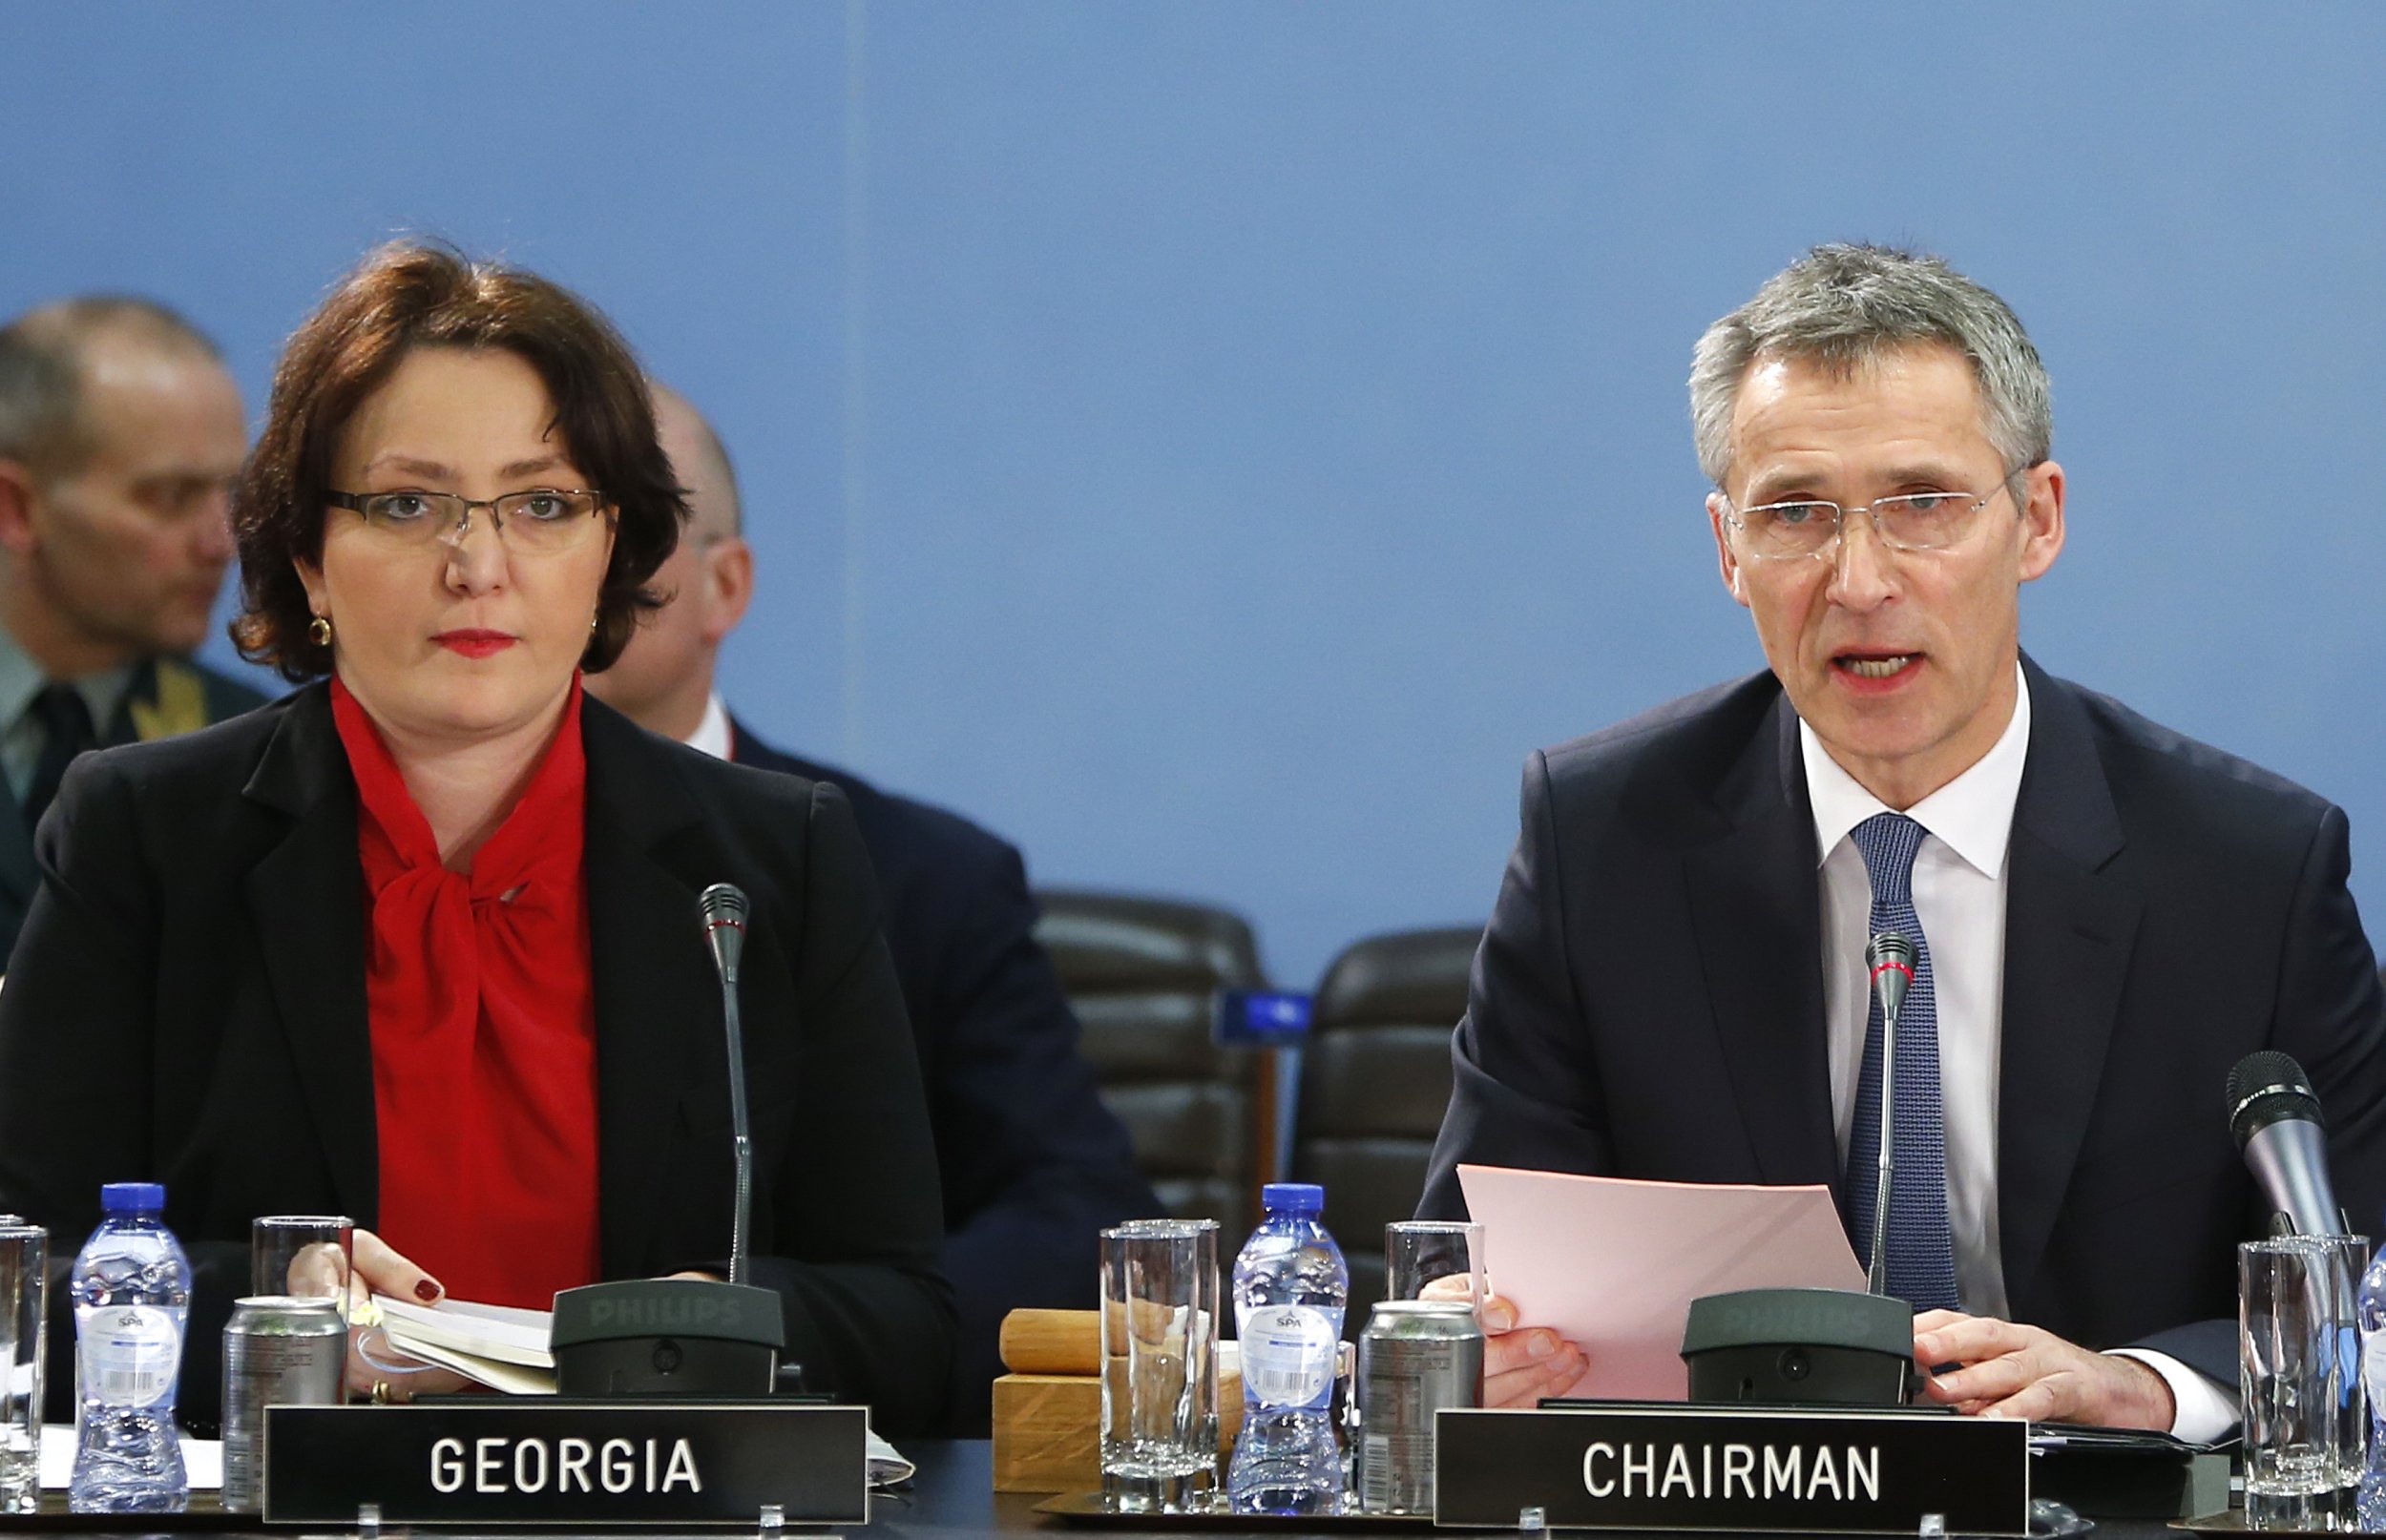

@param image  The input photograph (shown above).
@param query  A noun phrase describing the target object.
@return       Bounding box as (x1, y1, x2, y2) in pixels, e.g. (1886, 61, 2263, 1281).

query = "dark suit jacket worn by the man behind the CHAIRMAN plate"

(1425, 660, 2386, 1381)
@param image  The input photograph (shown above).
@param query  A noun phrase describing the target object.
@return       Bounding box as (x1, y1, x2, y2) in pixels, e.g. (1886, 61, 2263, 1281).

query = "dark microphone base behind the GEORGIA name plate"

(552, 1278, 787, 1397)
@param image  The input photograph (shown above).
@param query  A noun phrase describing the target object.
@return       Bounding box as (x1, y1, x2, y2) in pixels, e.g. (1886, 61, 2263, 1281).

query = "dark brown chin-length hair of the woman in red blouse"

(232, 240, 687, 682)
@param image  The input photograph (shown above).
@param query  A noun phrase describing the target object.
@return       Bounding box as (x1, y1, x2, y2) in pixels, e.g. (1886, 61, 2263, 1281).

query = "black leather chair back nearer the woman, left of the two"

(1036, 889, 1274, 1239)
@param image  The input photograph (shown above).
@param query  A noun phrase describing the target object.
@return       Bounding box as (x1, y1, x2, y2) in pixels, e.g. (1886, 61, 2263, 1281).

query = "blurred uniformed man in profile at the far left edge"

(0, 296, 265, 963)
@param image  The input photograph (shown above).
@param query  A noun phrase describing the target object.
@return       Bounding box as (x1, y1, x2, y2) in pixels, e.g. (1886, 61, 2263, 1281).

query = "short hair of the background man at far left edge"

(0, 293, 224, 474)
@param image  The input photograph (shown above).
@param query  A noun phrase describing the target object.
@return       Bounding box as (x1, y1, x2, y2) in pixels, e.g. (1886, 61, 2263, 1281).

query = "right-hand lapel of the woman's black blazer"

(582, 698, 721, 1278)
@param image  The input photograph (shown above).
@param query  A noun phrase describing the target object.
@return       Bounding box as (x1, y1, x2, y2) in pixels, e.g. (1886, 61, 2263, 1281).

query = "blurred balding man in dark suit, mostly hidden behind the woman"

(587, 386, 1160, 1433)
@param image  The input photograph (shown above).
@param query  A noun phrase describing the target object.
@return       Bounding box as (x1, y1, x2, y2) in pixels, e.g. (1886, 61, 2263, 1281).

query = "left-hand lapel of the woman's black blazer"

(243, 689, 380, 1225)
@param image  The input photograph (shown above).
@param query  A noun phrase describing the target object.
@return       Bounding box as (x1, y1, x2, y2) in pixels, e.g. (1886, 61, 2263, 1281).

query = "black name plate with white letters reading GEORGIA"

(265, 1395, 869, 1529)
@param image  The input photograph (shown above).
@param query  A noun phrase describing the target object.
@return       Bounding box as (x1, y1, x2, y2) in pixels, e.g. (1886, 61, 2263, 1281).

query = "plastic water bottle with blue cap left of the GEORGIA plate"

(67, 1182, 191, 1514)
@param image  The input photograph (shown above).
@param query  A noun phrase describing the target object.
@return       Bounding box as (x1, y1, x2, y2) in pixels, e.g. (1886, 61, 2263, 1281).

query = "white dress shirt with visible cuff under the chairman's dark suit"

(1799, 663, 2236, 1440)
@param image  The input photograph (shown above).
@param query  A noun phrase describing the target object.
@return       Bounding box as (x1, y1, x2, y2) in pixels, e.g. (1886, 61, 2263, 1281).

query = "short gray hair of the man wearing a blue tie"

(1689, 243, 2055, 489)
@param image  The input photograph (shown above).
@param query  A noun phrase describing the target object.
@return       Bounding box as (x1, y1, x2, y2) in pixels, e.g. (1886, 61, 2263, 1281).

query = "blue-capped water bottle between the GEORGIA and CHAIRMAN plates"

(1226, 1182, 1350, 1514)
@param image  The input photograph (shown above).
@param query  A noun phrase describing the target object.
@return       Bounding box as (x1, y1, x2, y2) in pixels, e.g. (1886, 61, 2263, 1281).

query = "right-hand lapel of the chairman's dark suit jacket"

(1998, 660, 2143, 1309)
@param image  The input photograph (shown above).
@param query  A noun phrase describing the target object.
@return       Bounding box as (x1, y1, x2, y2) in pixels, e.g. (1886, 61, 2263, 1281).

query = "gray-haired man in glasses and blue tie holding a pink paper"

(1422, 245, 2386, 1438)
